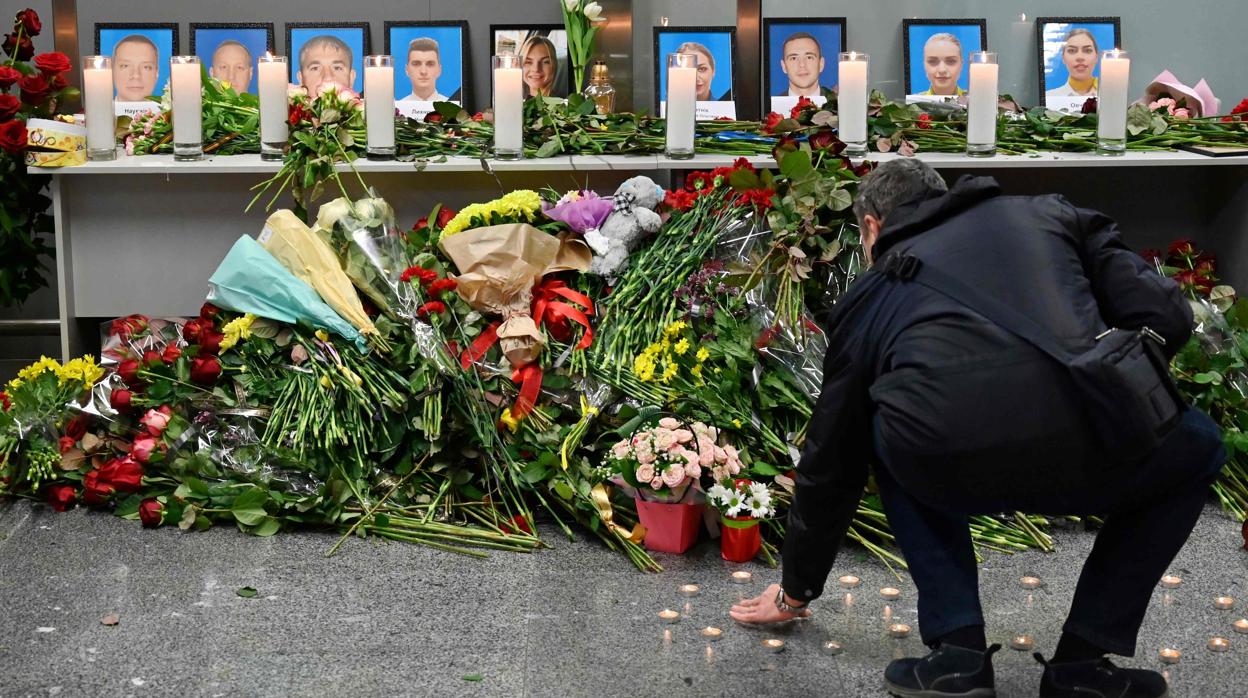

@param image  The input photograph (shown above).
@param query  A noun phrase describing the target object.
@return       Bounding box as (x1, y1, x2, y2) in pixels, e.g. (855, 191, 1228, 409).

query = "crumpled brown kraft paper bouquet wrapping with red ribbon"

(439, 224, 590, 368)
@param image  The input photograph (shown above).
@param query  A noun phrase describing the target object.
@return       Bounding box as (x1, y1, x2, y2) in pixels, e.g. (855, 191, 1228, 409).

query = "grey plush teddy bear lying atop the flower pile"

(585, 176, 663, 276)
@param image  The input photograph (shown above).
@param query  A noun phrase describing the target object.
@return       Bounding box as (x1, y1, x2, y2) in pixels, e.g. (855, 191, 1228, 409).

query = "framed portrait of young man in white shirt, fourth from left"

(386, 21, 472, 119)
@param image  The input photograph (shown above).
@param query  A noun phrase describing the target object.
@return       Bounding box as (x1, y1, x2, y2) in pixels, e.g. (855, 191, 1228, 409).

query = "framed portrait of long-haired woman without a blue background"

(489, 24, 572, 99)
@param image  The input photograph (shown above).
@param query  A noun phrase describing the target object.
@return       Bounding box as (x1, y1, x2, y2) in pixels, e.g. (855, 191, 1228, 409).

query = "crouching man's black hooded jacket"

(784, 176, 1192, 601)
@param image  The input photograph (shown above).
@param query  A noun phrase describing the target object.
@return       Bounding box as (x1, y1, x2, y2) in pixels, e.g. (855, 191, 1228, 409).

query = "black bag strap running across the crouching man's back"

(880, 252, 1073, 366)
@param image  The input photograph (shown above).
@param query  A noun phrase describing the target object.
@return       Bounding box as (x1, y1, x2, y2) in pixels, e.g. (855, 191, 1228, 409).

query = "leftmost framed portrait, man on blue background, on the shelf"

(95, 22, 180, 116)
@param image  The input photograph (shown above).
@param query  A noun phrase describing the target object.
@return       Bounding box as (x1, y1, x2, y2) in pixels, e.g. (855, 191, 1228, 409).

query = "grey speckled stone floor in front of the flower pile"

(0, 501, 1248, 698)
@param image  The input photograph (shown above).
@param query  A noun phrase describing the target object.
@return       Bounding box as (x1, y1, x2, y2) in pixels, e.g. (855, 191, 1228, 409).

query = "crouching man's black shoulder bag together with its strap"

(881, 252, 1184, 463)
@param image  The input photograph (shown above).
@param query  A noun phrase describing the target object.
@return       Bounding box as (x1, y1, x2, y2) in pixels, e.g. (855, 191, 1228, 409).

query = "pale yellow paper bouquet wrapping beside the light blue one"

(258, 209, 377, 335)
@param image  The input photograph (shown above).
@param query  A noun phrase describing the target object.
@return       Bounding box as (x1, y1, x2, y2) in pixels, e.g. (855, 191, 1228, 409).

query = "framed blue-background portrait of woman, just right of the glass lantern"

(654, 26, 736, 121)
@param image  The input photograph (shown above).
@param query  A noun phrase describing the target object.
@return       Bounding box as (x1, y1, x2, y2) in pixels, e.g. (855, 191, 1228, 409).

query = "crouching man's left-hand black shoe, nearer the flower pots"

(884, 644, 1001, 698)
